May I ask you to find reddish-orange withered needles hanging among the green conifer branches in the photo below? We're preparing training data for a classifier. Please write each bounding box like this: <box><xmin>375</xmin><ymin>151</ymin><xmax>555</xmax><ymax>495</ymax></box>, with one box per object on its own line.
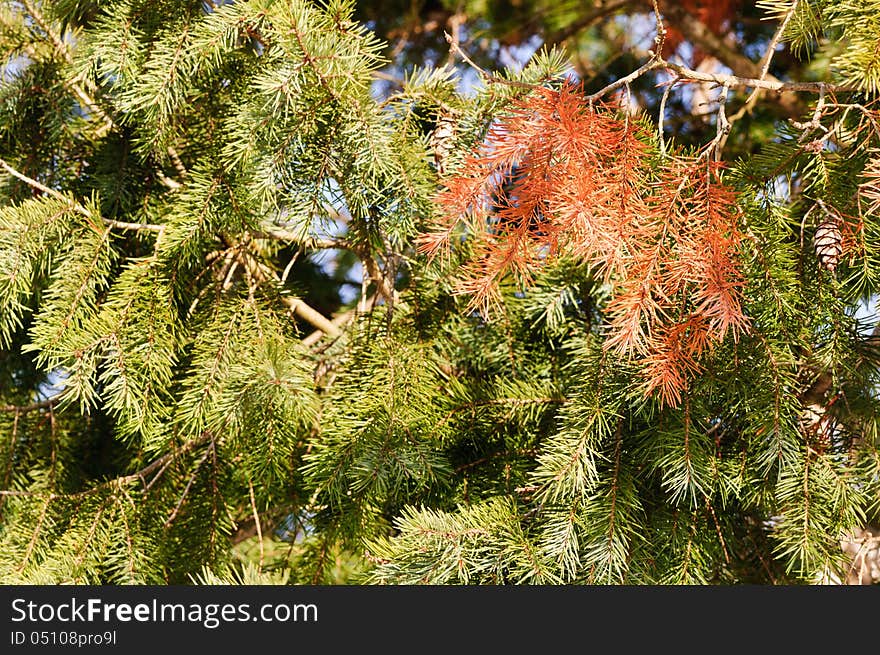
<box><xmin>419</xmin><ymin>85</ymin><xmax>748</xmax><ymax>405</ymax></box>
